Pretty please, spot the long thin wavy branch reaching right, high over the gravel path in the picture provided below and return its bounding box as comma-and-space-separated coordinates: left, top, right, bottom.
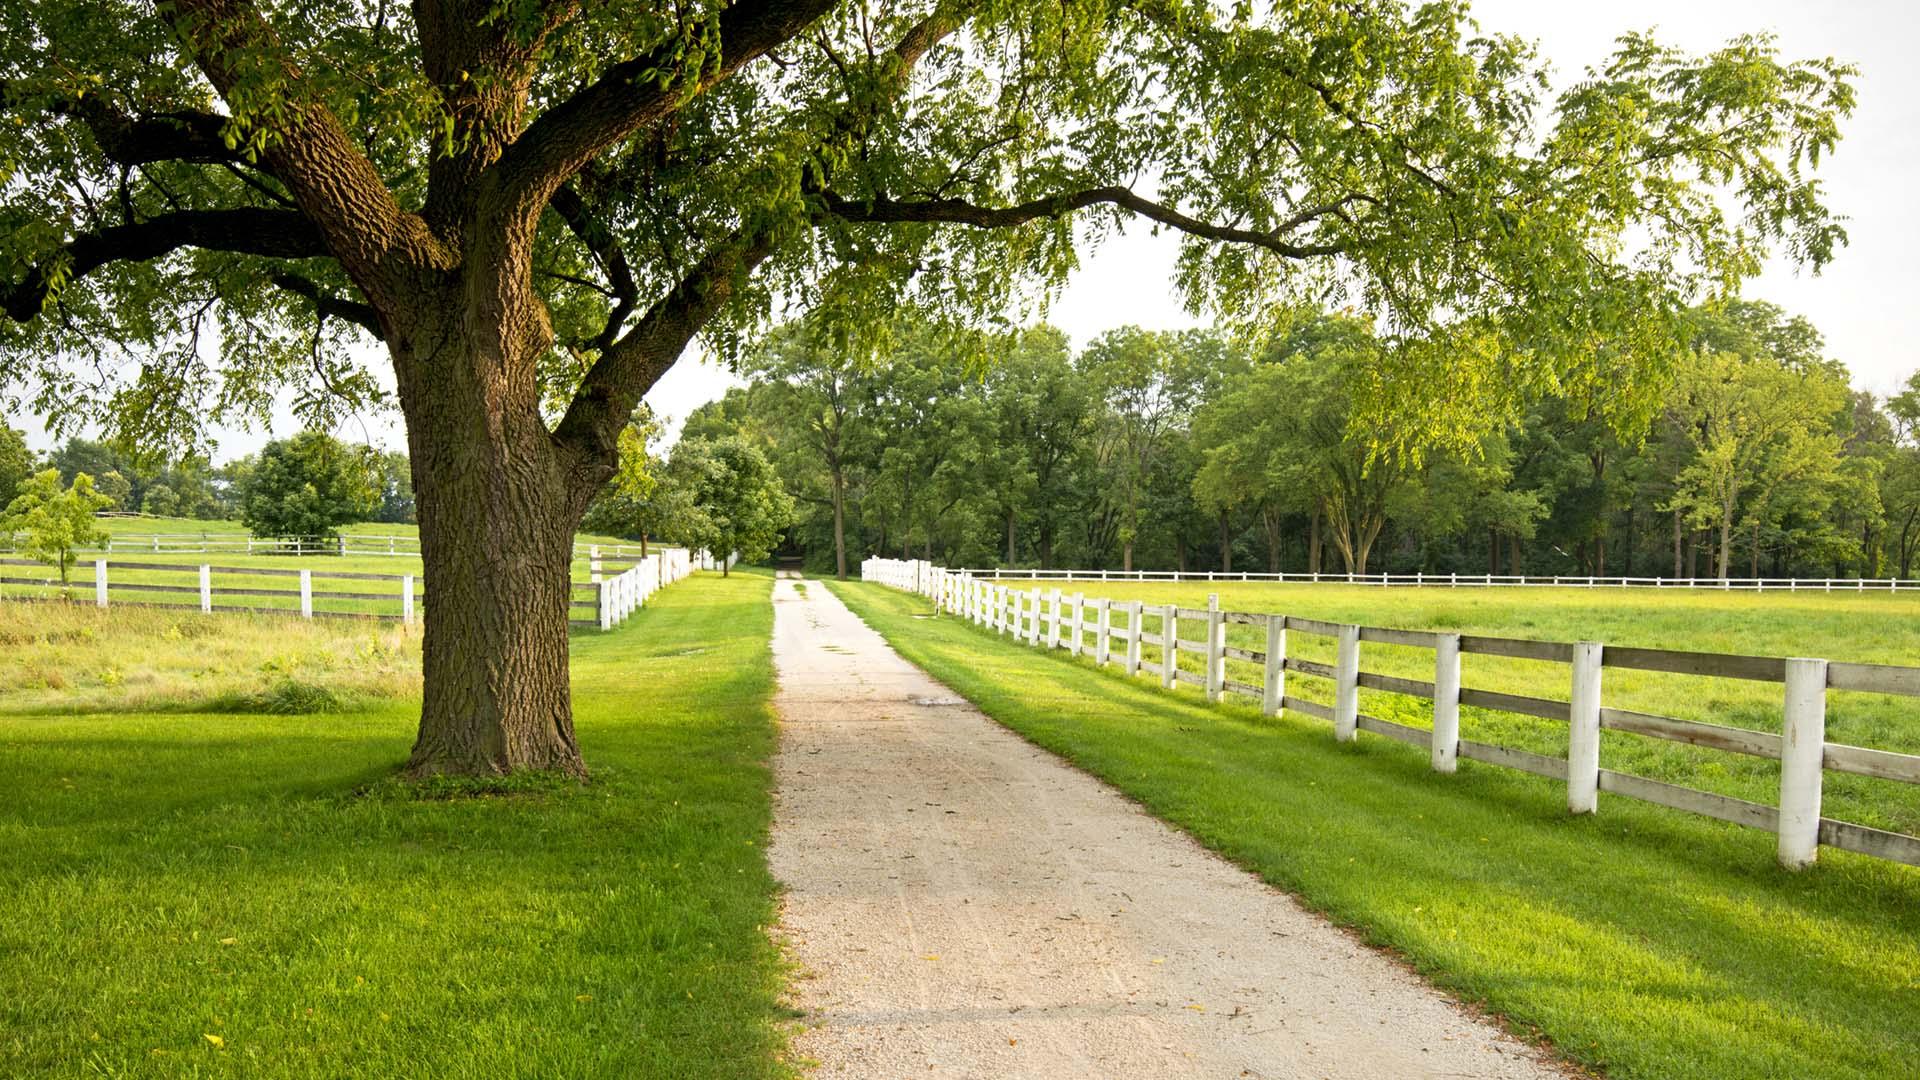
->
814, 186, 1346, 259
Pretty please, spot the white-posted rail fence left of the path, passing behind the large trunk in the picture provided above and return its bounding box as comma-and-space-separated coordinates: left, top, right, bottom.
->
0, 548, 716, 630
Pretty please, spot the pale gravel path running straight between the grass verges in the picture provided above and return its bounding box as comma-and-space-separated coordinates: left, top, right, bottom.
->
770, 580, 1563, 1080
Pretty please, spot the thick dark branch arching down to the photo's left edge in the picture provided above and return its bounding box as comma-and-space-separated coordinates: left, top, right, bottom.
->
0, 206, 328, 323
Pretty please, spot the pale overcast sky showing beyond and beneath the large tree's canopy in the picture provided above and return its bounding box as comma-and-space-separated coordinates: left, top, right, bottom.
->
13, 0, 1920, 459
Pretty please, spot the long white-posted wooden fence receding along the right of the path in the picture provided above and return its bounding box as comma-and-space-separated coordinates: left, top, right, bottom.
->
860, 559, 1920, 869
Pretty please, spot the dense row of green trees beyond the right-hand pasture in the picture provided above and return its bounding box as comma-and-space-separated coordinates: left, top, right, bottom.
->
685, 302, 1920, 577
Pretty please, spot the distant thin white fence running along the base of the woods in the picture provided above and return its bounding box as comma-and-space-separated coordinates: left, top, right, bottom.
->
952, 559, 1920, 592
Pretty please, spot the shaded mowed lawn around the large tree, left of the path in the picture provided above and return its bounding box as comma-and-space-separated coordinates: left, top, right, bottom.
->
0, 575, 783, 1078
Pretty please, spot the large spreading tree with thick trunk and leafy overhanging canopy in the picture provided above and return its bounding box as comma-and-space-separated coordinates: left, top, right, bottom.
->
0, 0, 1853, 773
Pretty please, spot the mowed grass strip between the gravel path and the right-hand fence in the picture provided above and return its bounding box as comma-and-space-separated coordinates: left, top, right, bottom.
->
833, 582, 1920, 1080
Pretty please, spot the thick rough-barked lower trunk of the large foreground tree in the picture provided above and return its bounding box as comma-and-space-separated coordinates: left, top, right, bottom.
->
394, 315, 591, 776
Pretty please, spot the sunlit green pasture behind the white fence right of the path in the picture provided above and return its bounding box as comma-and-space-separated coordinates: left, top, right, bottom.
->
975, 582, 1920, 834
